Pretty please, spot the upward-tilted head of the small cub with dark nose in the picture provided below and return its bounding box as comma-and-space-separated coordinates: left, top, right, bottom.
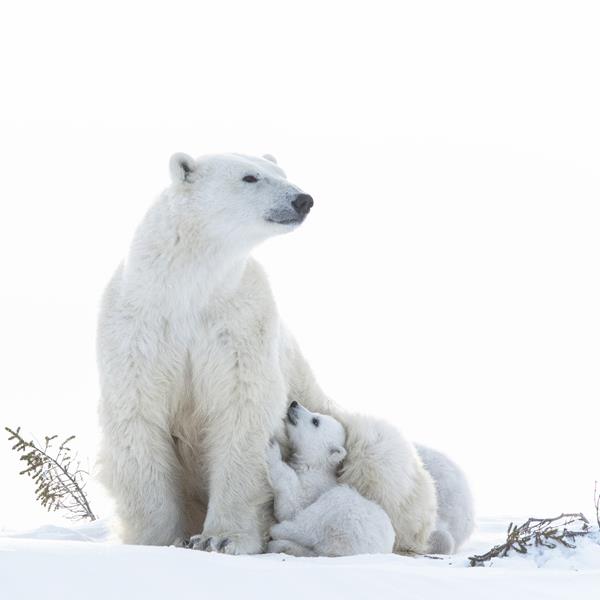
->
286, 402, 346, 470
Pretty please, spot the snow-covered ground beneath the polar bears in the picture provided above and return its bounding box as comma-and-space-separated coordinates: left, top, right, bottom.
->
0, 519, 600, 600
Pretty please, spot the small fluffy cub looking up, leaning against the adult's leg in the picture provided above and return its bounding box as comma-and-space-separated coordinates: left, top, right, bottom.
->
267, 402, 395, 556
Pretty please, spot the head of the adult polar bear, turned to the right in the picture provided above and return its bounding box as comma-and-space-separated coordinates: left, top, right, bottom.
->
170, 154, 313, 244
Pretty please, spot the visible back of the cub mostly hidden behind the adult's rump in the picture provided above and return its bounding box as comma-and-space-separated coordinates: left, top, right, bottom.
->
417, 445, 475, 554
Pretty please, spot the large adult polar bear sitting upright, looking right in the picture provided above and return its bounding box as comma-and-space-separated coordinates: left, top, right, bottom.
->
98, 154, 436, 554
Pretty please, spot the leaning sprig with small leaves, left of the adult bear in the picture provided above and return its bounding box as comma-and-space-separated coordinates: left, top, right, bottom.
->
5, 427, 96, 521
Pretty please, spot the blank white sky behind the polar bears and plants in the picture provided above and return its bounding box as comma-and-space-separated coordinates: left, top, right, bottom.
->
0, 0, 600, 526
